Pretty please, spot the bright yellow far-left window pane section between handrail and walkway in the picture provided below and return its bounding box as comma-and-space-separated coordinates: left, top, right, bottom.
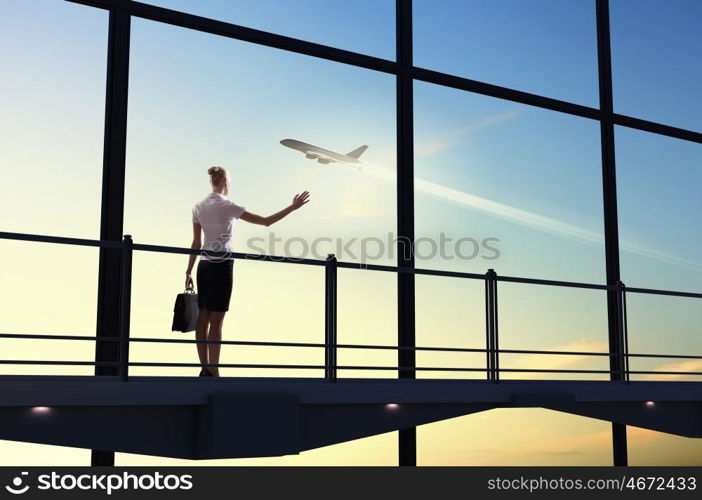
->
0, 240, 98, 375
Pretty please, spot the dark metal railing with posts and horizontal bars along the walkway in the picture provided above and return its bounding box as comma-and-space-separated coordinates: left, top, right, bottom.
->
0, 232, 702, 383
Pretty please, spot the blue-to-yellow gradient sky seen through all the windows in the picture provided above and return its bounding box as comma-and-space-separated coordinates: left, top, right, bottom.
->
0, 0, 702, 465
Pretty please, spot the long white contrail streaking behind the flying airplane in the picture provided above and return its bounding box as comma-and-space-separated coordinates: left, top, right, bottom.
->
362, 163, 702, 272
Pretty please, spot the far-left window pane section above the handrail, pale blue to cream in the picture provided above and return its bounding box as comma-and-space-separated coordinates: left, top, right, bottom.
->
0, 0, 108, 238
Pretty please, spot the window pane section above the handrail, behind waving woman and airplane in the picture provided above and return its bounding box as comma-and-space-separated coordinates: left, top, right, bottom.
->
125, 19, 396, 263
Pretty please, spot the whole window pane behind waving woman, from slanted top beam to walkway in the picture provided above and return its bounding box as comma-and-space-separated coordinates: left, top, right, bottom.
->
125, 19, 396, 377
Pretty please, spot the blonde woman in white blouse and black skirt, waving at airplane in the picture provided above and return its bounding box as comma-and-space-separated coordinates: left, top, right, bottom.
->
185, 167, 310, 377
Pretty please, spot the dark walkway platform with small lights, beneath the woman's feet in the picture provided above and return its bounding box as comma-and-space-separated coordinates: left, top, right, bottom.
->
0, 375, 702, 459
